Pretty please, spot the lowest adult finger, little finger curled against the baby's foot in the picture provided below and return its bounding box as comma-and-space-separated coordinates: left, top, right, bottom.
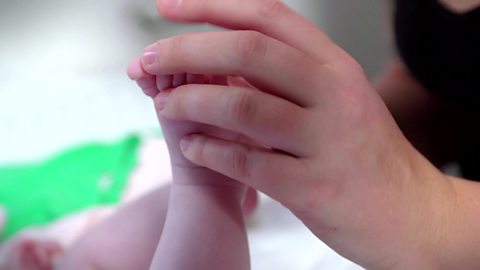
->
180, 135, 308, 205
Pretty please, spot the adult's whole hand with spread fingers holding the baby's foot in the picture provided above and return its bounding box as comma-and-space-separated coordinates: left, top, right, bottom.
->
142, 0, 454, 269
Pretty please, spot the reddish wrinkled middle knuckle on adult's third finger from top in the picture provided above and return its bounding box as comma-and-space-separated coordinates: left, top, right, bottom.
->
227, 92, 257, 124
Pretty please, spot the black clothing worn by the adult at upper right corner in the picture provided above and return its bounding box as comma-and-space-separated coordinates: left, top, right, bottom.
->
395, 0, 480, 181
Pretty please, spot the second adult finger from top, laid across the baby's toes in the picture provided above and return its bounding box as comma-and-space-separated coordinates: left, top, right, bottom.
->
142, 31, 322, 106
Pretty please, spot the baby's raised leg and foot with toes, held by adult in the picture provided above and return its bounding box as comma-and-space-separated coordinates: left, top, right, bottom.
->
128, 60, 250, 270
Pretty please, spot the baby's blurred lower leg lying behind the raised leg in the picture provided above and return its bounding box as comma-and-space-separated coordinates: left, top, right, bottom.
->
55, 186, 170, 270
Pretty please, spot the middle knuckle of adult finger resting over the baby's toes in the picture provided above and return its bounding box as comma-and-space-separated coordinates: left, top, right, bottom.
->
236, 30, 267, 66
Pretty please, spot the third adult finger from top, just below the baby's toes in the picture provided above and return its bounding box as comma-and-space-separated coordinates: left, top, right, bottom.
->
154, 85, 315, 157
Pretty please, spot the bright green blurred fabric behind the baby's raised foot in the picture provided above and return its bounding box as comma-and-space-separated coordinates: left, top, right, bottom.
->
0, 136, 140, 239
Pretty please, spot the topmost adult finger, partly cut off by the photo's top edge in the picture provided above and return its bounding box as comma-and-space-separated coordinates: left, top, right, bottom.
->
157, 0, 346, 63
